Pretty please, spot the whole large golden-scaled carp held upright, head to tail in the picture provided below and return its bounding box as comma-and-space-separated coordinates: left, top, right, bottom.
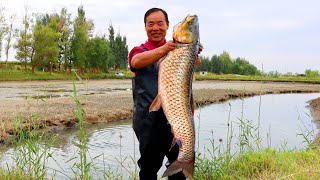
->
149, 15, 200, 179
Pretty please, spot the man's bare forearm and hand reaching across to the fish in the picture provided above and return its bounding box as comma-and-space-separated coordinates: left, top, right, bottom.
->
131, 41, 177, 69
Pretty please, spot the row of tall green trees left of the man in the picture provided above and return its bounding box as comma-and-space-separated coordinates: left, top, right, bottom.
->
0, 6, 128, 73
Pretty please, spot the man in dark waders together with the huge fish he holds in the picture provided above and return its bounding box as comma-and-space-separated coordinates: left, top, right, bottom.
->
129, 8, 202, 180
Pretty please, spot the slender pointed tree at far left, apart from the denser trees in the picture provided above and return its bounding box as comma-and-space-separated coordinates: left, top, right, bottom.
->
14, 7, 34, 69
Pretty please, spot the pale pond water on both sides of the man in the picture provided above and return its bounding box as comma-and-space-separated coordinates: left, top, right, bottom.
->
2, 93, 320, 179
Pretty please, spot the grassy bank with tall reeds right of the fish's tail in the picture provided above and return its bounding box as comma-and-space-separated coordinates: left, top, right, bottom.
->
194, 91, 320, 180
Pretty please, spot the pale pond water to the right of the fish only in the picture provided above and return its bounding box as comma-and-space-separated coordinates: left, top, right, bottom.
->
196, 93, 320, 152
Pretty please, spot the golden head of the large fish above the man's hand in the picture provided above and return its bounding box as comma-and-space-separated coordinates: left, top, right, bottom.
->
172, 15, 199, 44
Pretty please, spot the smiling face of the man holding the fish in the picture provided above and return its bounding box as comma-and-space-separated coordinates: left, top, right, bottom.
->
145, 11, 169, 43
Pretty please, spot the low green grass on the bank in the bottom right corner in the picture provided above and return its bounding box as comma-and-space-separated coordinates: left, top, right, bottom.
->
194, 147, 320, 180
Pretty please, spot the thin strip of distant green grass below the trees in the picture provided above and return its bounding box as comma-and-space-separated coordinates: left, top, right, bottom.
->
0, 63, 320, 84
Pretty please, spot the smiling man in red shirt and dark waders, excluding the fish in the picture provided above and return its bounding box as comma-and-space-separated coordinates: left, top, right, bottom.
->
129, 8, 200, 180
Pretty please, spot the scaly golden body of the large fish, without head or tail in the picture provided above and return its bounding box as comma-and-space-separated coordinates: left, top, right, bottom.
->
159, 45, 198, 162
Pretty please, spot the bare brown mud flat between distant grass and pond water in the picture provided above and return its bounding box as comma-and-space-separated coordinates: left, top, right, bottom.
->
0, 80, 320, 140
